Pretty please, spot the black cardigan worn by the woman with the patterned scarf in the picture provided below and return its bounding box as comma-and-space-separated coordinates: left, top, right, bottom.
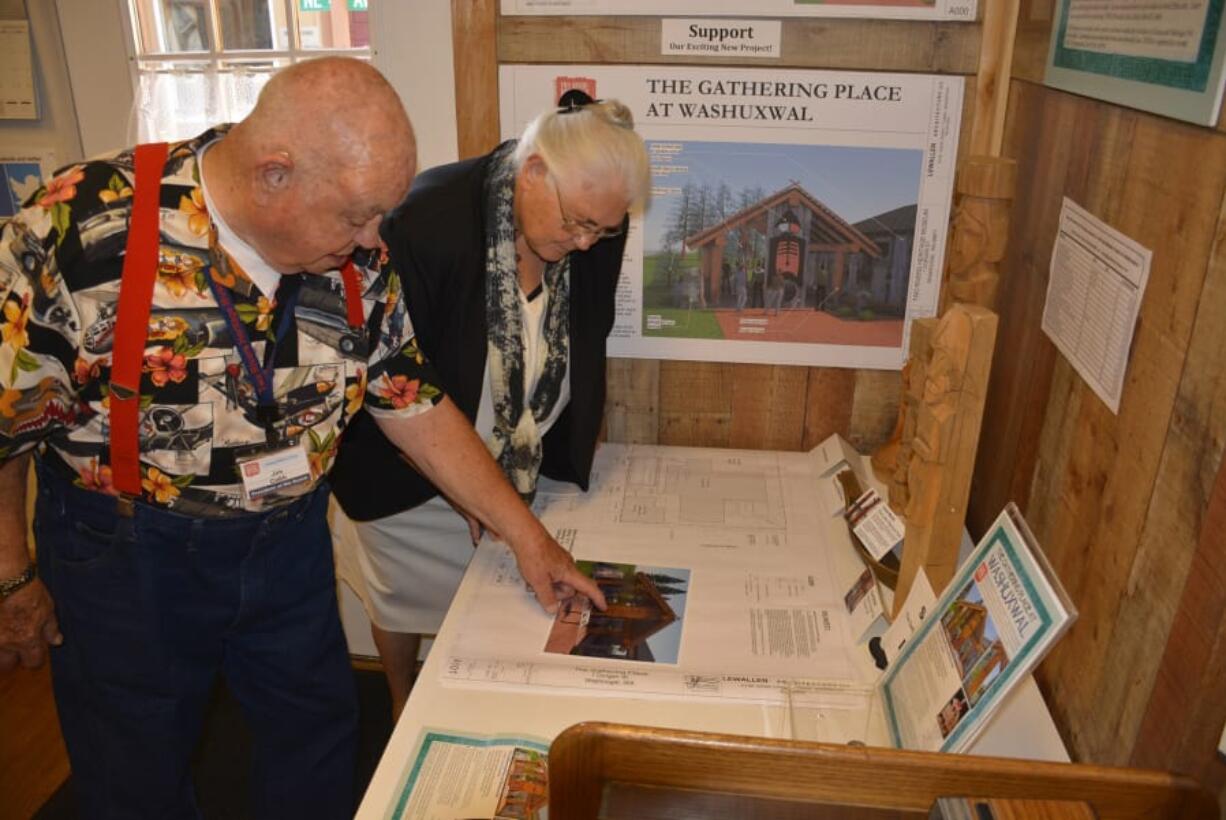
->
331, 144, 625, 521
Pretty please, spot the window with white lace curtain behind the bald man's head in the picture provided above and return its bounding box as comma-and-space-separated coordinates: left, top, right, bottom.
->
128, 0, 370, 142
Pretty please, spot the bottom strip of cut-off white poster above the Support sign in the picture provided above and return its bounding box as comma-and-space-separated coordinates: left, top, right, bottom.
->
503, 0, 976, 22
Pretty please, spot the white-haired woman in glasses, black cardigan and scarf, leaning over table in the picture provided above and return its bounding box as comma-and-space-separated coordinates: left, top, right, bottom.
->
331, 91, 651, 716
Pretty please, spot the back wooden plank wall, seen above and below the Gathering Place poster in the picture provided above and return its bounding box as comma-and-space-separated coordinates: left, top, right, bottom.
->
452, 0, 990, 451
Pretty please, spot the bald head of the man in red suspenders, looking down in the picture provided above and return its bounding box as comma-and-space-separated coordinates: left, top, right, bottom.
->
206, 58, 417, 272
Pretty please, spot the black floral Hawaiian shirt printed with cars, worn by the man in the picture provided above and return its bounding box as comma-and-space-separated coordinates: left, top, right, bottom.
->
0, 126, 443, 516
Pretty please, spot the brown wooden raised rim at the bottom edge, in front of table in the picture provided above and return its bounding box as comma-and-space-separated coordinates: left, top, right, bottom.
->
549, 723, 1219, 820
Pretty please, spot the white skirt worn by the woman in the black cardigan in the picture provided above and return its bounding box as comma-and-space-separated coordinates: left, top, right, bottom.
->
332, 496, 473, 635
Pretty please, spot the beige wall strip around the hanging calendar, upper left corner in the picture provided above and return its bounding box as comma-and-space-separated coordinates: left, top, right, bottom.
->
0, 0, 82, 165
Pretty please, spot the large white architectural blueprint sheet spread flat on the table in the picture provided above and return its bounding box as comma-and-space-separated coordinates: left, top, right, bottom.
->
441, 445, 873, 708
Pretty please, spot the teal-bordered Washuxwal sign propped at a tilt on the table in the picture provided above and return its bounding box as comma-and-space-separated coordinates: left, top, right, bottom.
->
790, 504, 1076, 751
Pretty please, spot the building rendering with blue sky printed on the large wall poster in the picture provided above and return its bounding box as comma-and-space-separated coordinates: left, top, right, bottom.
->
642, 141, 923, 347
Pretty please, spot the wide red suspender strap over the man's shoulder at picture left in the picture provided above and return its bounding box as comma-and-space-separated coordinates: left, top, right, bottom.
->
110, 142, 168, 496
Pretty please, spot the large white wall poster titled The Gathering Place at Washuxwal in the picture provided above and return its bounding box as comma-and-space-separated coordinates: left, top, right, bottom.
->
499, 65, 964, 369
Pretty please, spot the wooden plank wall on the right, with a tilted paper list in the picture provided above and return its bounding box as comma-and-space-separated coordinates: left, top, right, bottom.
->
969, 0, 1226, 804
